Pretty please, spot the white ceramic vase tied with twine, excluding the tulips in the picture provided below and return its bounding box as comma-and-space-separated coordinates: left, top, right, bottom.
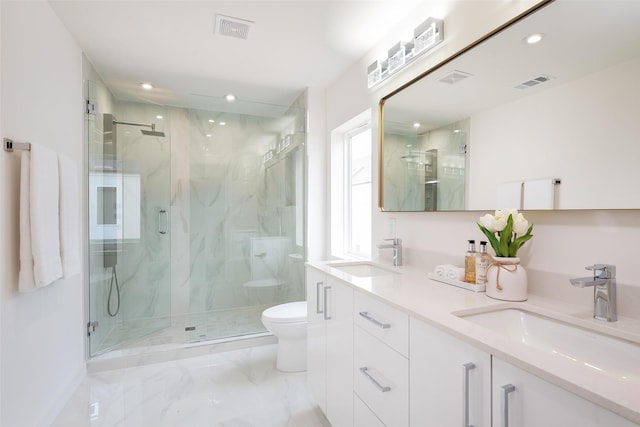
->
486, 257, 527, 301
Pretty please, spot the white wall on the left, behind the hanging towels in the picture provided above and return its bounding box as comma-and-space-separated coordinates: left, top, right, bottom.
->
0, 1, 86, 427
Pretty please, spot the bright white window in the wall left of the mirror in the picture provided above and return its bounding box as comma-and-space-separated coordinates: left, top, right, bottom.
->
330, 110, 373, 258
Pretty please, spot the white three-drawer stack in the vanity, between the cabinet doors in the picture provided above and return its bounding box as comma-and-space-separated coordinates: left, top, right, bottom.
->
352, 291, 409, 427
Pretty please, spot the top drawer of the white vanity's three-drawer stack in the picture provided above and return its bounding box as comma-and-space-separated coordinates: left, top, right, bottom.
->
354, 292, 409, 357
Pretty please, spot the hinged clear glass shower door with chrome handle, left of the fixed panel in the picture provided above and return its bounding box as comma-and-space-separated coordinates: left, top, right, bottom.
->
87, 81, 171, 356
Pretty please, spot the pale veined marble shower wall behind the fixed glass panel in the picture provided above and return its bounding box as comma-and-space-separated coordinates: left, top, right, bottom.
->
184, 104, 303, 313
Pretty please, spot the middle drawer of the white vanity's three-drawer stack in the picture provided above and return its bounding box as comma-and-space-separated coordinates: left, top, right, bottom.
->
353, 326, 409, 427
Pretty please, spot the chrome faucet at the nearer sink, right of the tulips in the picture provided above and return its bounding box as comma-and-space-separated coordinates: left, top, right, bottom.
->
569, 264, 618, 322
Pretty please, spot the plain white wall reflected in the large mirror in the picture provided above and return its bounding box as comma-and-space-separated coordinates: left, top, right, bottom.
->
467, 59, 640, 209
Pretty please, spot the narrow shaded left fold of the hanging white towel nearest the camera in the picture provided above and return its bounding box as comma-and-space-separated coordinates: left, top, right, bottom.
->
18, 151, 36, 292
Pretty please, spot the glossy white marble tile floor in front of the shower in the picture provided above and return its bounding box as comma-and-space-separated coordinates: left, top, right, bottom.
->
52, 344, 330, 427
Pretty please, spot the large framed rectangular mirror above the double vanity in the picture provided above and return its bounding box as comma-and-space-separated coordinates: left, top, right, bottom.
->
379, 0, 640, 211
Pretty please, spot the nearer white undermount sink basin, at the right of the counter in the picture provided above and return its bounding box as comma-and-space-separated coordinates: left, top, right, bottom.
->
457, 308, 640, 381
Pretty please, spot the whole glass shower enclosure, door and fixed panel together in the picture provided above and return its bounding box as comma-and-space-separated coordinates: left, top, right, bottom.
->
87, 80, 305, 356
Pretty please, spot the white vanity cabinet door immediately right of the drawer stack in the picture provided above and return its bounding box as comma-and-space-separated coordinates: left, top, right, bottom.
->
409, 317, 491, 427
